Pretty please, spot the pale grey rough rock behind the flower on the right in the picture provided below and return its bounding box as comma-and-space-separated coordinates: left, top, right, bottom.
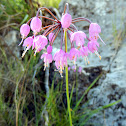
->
59, 0, 126, 126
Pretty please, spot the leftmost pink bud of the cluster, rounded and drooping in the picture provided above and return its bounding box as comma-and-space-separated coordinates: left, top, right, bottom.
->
20, 24, 30, 38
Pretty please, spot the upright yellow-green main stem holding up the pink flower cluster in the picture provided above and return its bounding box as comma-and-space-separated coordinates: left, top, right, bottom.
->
64, 30, 72, 126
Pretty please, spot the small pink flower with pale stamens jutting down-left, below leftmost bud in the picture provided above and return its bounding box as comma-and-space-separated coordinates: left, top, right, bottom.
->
22, 37, 33, 57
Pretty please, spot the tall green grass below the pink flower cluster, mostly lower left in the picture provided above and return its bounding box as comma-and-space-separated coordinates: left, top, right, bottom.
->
0, 45, 120, 126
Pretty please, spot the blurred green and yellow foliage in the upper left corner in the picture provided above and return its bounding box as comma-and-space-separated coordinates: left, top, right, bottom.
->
0, 0, 61, 30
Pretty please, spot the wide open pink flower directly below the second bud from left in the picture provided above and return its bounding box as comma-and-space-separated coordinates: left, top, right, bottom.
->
32, 35, 48, 54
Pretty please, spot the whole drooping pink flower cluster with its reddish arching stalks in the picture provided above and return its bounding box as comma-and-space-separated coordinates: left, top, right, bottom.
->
19, 4, 102, 76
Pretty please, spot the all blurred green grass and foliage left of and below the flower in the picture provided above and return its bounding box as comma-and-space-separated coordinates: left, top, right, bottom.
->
0, 0, 119, 126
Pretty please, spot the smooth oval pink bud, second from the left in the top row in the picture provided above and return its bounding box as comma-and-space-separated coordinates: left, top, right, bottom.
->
30, 17, 42, 33
